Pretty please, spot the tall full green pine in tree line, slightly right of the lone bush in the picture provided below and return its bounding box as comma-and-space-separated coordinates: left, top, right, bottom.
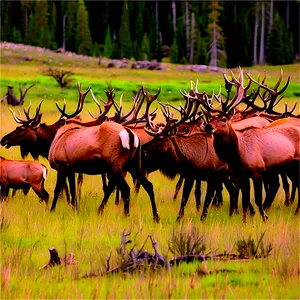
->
75, 0, 92, 55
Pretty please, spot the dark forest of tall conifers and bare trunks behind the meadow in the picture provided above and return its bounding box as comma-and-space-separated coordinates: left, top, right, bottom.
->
1, 0, 300, 67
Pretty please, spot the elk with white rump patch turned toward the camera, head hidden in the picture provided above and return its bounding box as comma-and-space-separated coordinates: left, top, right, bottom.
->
48, 90, 159, 221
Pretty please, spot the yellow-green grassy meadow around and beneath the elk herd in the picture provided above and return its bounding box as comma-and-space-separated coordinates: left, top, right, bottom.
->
0, 43, 300, 299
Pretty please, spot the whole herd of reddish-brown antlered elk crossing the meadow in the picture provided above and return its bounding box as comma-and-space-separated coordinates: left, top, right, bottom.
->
0, 68, 300, 222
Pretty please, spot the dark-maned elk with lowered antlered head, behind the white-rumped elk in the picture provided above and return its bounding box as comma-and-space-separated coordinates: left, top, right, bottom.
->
142, 88, 237, 221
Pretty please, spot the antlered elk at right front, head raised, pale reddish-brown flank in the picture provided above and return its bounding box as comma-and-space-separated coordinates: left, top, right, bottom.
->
202, 69, 300, 222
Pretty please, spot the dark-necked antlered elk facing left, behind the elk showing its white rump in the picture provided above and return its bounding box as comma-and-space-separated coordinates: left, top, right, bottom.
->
1, 82, 90, 203
